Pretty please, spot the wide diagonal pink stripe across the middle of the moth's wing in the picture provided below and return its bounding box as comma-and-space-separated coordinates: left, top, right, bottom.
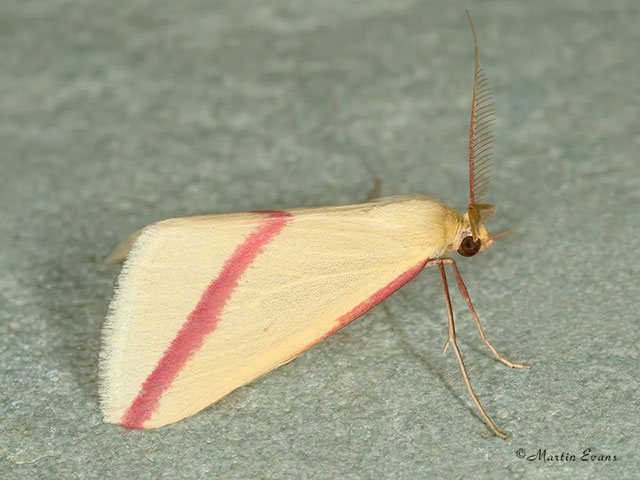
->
121, 210, 293, 428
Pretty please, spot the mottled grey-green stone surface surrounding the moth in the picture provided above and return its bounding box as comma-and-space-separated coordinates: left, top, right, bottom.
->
0, 0, 640, 479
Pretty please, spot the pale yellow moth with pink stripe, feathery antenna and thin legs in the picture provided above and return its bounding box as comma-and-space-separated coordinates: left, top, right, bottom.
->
100, 14, 528, 438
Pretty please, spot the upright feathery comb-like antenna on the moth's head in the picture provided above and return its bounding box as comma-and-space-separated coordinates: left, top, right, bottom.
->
466, 10, 495, 205
